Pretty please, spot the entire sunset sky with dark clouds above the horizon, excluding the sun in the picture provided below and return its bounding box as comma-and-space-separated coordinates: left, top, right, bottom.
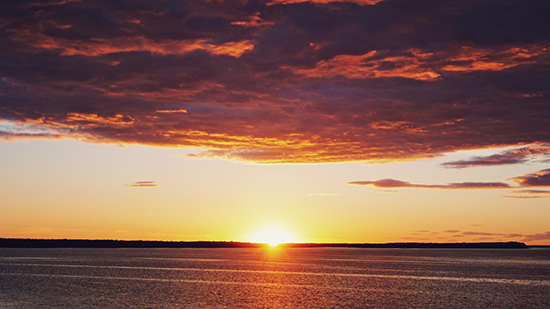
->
0, 0, 550, 245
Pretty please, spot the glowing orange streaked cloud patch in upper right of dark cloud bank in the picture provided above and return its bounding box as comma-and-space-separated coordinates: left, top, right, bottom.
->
292, 45, 550, 82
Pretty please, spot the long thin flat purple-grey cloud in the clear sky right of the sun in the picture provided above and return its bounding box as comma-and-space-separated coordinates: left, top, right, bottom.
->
348, 178, 510, 190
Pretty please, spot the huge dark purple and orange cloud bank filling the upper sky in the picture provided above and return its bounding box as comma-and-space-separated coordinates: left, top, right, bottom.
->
0, 0, 550, 162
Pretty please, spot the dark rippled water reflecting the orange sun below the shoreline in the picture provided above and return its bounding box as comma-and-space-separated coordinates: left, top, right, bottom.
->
0, 248, 550, 308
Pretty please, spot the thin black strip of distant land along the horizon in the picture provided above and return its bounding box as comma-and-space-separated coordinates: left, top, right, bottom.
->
0, 238, 529, 249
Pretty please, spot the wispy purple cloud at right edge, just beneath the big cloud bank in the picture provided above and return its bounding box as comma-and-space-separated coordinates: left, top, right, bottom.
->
441, 144, 550, 168
